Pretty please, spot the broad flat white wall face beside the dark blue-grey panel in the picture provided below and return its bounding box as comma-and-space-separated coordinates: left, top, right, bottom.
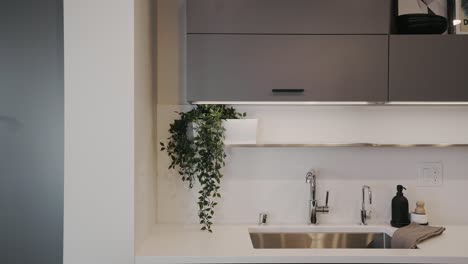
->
64, 0, 135, 264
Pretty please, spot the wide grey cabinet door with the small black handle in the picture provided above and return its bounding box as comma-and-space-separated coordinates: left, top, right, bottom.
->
187, 34, 388, 102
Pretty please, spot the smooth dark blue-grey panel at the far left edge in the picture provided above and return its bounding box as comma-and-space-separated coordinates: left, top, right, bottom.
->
0, 0, 64, 264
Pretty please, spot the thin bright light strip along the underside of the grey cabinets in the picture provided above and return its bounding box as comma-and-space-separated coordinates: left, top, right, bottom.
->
192, 101, 468, 106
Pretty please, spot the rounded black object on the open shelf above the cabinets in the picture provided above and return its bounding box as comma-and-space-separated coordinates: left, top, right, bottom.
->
396, 14, 448, 34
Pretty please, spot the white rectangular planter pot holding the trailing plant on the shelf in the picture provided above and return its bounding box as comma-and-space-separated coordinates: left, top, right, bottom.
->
188, 119, 258, 145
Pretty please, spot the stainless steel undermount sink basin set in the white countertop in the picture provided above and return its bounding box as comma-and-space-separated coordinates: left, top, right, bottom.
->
250, 232, 392, 249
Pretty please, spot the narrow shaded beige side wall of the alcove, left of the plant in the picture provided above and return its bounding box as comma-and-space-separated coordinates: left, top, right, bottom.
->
135, 0, 157, 251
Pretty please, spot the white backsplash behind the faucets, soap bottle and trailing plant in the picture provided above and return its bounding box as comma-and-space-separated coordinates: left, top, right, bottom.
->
157, 105, 468, 224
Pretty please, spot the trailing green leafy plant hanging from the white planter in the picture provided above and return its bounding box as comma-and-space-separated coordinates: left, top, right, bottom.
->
160, 105, 246, 232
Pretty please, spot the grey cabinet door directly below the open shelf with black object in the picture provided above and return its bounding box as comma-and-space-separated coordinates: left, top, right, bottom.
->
390, 35, 468, 102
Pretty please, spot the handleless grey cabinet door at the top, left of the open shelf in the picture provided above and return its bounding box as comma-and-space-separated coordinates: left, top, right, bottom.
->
187, 0, 391, 34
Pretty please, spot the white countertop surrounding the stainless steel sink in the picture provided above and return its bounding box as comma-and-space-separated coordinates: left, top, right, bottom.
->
136, 225, 468, 264
